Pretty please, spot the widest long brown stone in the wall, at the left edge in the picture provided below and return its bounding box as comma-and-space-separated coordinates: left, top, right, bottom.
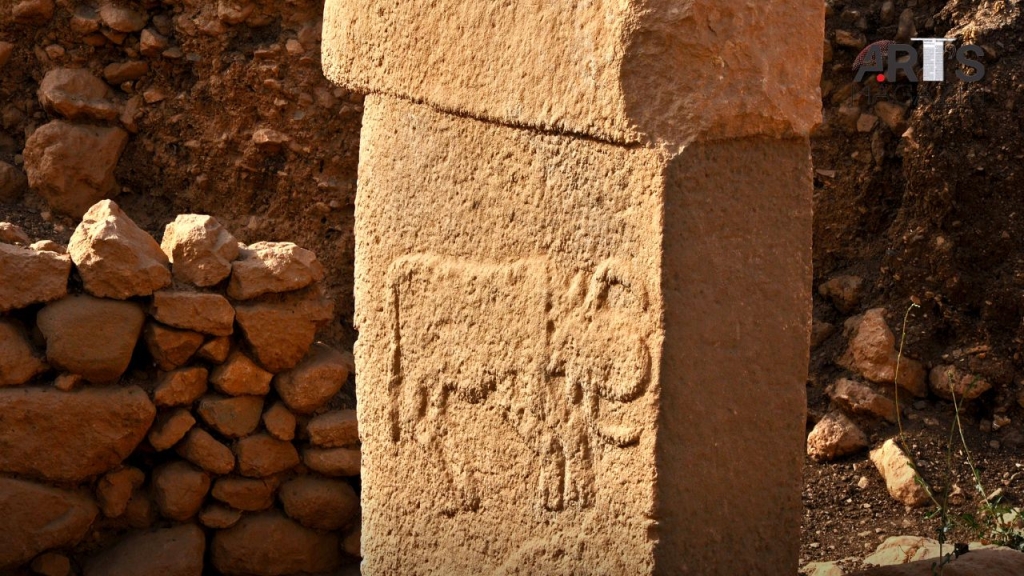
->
0, 386, 156, 482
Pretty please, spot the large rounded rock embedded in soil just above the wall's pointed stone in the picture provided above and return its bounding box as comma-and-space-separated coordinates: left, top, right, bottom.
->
25, 120, 128, 218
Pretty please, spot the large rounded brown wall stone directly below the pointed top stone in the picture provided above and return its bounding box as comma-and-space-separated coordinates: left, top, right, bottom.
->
37, 295, 145, 382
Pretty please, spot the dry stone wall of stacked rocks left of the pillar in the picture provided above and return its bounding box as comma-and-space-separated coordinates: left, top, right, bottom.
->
0, 200, 360, 576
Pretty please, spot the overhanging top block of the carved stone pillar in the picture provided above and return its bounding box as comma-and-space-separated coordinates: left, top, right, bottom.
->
323, 0, 824, 145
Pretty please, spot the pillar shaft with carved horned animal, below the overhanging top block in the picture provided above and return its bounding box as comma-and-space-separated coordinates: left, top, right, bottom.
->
354, 96, 820, 575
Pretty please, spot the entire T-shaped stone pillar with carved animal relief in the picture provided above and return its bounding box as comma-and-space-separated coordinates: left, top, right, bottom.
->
324, 0, 824, 576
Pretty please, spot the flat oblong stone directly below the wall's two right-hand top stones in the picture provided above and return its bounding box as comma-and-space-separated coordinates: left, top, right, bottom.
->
150, 290, 234, 336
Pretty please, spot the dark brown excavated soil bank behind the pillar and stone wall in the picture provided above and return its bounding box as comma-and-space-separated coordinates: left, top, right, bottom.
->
6, 0, 1024, 563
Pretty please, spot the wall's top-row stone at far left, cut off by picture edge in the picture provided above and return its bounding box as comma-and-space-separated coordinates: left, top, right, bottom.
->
0, 239, 71, 312
